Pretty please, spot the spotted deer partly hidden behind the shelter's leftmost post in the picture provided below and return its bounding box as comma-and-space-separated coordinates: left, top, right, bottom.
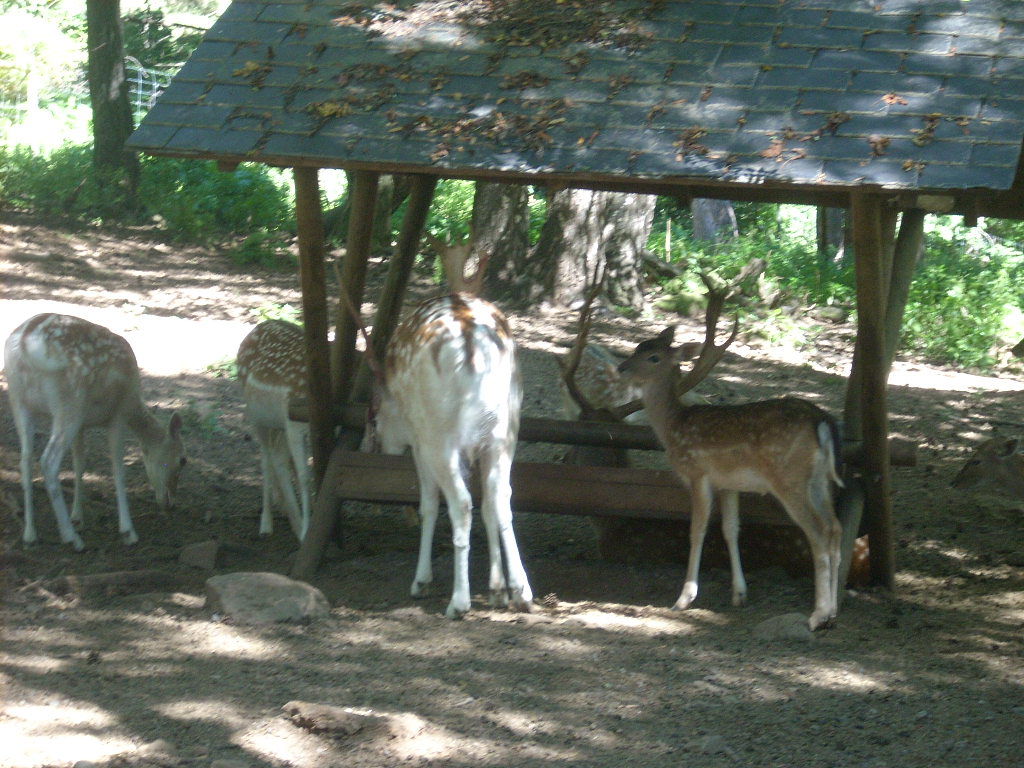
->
237, 319, 312, 541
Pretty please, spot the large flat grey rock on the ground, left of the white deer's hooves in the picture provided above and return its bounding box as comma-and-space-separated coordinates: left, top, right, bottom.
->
206, 572, 331, 624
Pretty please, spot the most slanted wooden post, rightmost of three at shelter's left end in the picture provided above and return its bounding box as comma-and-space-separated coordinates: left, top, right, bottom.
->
351, 176, 437, 402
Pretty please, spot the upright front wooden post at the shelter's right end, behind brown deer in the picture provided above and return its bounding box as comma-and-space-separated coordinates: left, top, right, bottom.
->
850, 193, 896, 589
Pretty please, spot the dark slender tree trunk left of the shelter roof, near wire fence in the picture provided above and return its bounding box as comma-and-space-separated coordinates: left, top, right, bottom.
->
86, 0, 139, 204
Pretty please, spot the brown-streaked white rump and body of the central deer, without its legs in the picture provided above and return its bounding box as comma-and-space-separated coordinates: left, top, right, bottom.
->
377, 294, 522, 453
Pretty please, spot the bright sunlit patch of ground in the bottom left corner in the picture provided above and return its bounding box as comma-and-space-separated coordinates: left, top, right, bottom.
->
0, 701, 134, 768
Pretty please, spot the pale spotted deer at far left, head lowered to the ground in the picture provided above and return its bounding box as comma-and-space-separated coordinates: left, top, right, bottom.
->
4, 313, 187, 551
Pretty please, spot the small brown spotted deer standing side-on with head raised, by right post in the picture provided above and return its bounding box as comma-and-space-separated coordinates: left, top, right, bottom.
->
620, 292, 843, 630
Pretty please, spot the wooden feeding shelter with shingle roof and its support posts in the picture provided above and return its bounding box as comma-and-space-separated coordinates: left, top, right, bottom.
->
129, 0, 1024, 586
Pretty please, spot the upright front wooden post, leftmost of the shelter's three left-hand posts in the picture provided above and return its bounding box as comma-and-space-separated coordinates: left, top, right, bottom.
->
293, 168, 335, 482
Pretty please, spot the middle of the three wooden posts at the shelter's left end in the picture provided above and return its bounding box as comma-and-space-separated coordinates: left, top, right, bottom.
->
332, 171, 380, 402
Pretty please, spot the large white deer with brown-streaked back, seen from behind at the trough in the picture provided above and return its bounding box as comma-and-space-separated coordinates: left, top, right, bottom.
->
367, 293, 534, 618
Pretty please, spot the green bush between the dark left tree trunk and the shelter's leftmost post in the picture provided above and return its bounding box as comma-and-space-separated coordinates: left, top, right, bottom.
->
140, 158, 295, 240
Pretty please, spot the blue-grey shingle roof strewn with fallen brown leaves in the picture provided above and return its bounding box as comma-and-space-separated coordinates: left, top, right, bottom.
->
129, 0, 1024, 195
